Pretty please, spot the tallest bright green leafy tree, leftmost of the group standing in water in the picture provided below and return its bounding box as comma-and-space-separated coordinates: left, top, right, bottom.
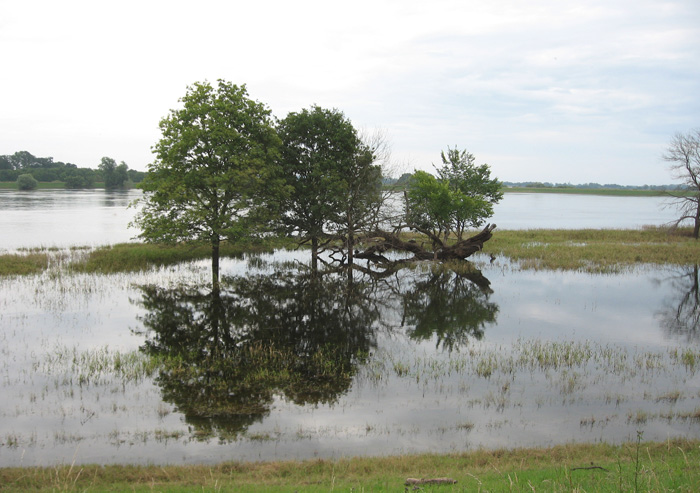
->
134, 80, 279, 290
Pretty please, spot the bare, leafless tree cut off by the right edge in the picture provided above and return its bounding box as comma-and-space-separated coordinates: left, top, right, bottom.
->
664, 129, 700, 240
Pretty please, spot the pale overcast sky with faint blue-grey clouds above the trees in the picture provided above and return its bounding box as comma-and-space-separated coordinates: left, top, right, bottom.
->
0, 0, 700, 185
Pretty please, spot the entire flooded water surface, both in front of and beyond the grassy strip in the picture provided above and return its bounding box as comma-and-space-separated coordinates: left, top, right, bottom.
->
0, 191, 700, 466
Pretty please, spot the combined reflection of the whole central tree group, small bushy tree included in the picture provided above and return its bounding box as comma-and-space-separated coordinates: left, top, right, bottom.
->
139, 269, 498, 440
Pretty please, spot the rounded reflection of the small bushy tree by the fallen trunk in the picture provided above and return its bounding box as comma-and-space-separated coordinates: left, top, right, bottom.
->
402, 268, 498, 350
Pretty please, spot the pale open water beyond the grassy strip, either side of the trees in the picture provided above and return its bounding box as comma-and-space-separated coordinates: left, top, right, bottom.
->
0, 190, 675, 251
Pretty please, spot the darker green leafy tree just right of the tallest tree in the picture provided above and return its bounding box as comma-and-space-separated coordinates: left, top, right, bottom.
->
278, 106, 381, 268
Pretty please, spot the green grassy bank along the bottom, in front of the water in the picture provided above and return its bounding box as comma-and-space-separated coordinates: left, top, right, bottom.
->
0, 440, 700, 492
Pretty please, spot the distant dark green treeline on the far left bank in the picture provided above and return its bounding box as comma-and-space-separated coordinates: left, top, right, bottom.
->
0, 151, 146, 188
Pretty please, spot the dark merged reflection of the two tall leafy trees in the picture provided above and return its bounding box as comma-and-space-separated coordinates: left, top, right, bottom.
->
135, 272, 378, 439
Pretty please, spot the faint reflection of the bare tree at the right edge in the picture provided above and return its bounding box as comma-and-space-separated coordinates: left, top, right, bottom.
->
661, 265, 700, 342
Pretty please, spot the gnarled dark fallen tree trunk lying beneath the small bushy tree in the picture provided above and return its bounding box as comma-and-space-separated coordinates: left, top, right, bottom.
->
355, 224, 496, 262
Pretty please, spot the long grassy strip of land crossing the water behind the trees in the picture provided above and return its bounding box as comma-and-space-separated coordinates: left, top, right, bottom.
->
0, 228, 700, 276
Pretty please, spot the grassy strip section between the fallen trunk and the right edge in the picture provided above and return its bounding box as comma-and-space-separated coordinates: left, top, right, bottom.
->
484, 228, 700, 272
